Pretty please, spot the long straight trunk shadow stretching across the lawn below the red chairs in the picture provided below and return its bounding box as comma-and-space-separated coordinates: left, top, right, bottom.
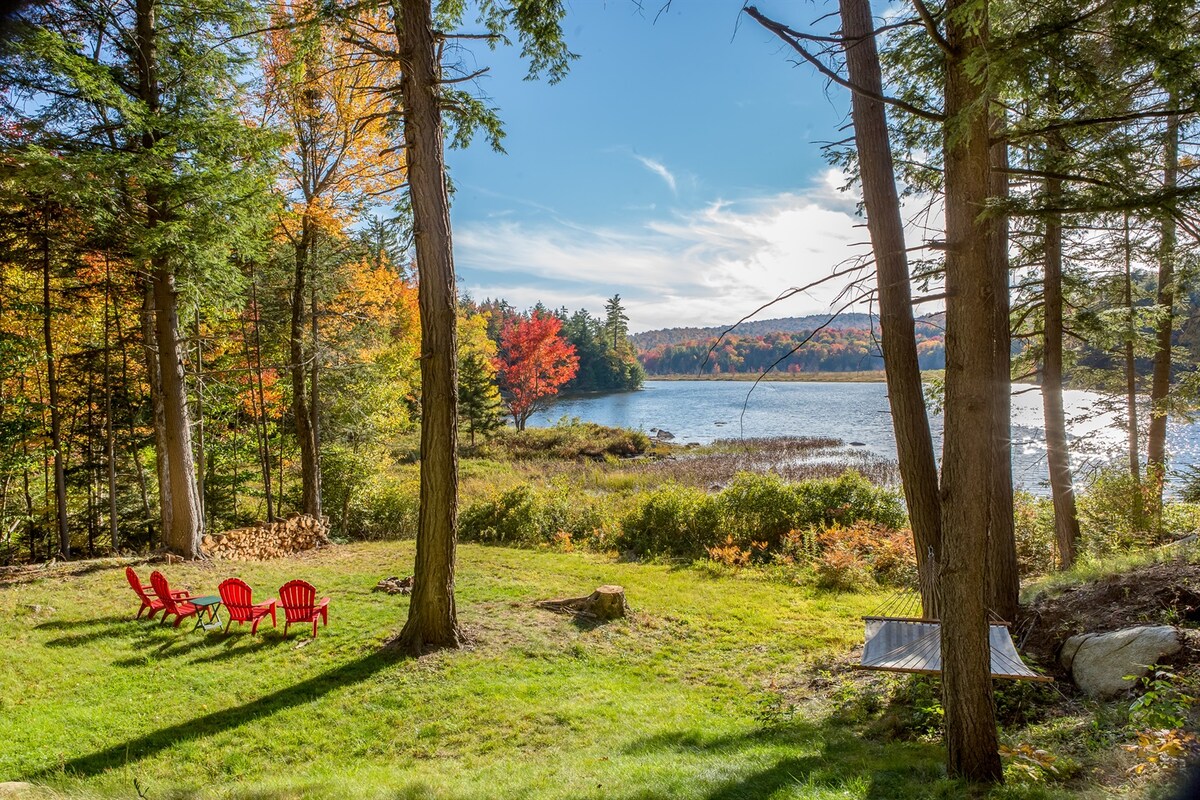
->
25, 649, 406, 782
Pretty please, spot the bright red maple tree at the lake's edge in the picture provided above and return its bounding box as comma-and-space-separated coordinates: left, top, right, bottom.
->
496, 311, 580, 431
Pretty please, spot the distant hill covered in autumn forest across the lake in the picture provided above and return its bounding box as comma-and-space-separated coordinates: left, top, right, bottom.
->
631, 314, 946, 375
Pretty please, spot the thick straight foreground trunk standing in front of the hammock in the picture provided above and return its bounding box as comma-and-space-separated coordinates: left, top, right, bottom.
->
938, 0, 1002, 781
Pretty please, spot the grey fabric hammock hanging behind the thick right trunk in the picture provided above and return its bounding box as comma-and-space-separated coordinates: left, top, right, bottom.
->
858, 591, 1054, 682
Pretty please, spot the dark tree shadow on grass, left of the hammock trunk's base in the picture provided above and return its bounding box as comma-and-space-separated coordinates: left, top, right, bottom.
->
625, 720, 959, 800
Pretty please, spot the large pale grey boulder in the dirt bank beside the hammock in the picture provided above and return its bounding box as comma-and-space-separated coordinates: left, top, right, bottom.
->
1060, 625, 1183, 698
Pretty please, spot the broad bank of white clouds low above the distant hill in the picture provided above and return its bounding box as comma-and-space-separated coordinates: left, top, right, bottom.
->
455, 169, 931, 331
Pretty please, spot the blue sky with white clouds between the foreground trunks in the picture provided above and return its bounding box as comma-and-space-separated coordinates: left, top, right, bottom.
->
448, 0, 866, 331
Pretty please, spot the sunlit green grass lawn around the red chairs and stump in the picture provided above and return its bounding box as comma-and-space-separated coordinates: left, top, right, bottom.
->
0, 542, 1142, 800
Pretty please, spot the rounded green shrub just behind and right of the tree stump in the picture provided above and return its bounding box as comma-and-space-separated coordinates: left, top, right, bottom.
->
613, 483, 721, 558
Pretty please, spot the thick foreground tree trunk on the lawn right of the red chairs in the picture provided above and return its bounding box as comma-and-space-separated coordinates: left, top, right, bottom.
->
392, 0, 462, 654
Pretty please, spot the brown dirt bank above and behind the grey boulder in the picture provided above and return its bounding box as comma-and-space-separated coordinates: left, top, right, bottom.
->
1013, 561, 1200, 674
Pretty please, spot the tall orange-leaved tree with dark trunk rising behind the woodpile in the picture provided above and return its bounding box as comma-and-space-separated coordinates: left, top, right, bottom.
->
262, 0, 404, 517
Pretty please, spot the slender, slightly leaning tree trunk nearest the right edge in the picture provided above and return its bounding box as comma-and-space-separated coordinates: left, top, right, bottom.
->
1146, 112, 1180, 506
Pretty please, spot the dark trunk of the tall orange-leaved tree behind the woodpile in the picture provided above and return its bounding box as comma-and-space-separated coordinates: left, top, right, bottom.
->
290, 220, 320, 518
